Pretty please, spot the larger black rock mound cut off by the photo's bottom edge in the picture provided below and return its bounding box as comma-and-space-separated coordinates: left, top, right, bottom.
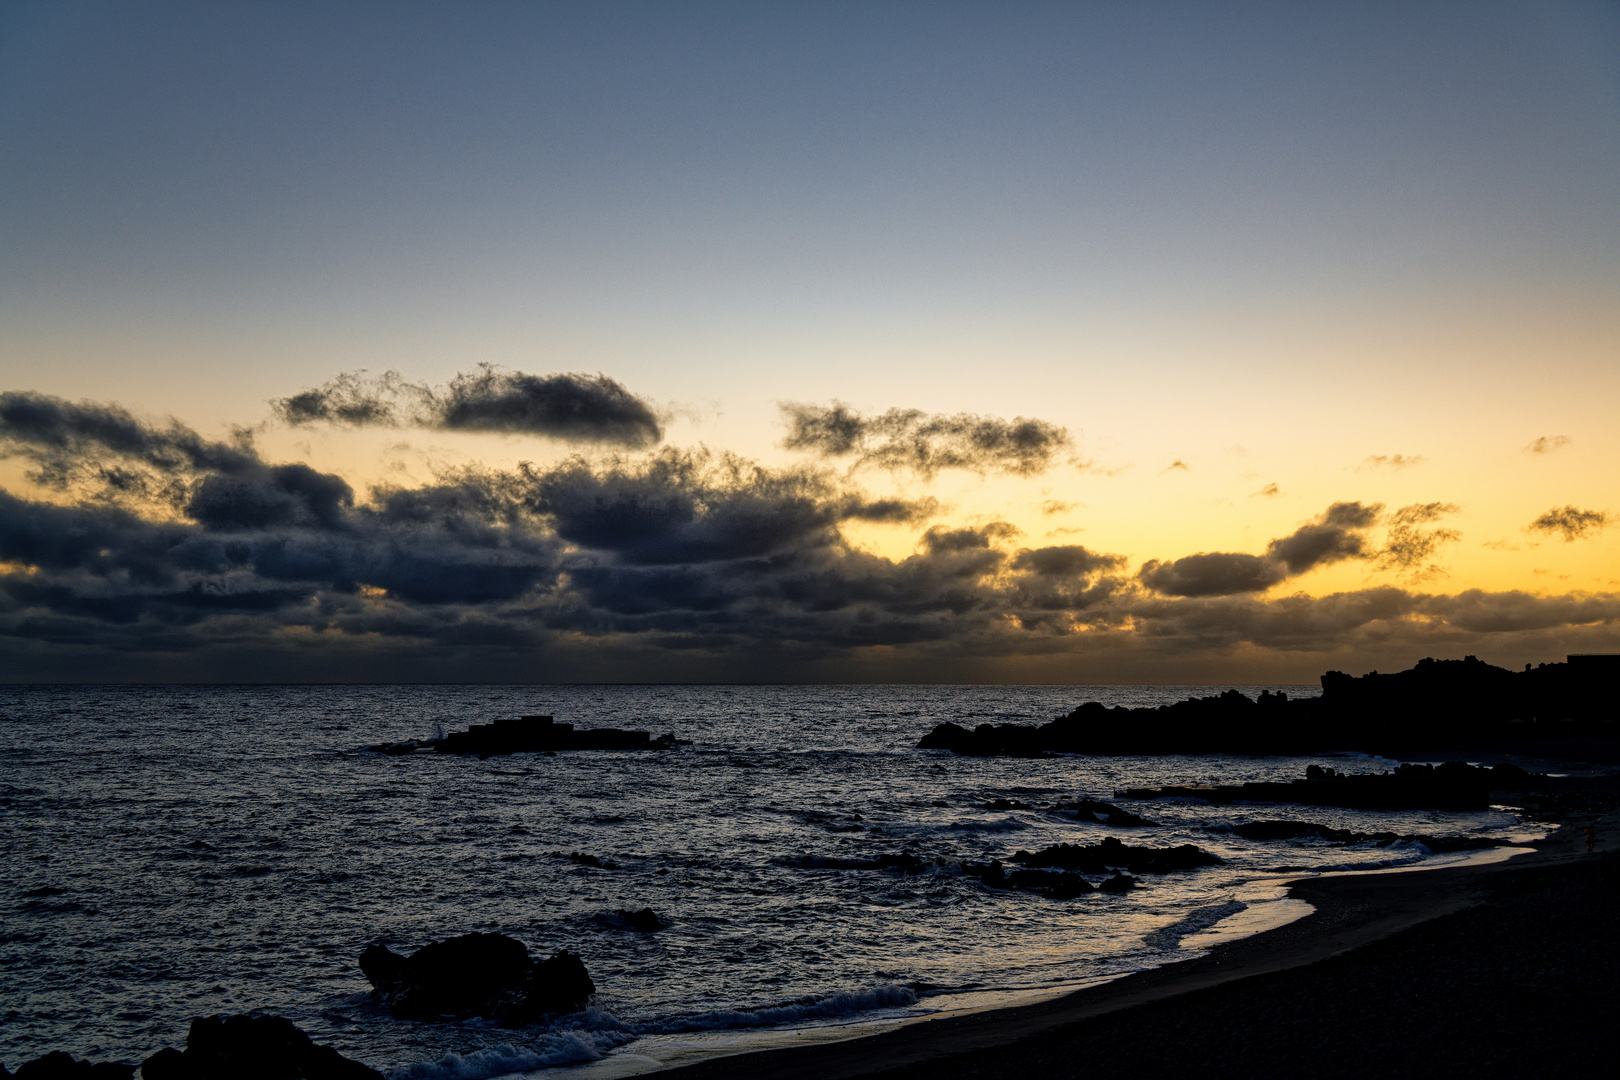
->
136, 1015, 382, 1080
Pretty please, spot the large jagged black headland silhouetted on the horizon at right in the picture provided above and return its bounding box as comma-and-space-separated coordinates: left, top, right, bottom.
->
917, 656, 1620, 761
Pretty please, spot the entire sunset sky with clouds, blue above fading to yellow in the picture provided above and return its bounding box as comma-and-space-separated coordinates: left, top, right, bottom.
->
0, 2, 1620, 683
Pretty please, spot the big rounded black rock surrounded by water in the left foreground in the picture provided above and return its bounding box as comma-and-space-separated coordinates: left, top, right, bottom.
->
360, 934, 596, 1027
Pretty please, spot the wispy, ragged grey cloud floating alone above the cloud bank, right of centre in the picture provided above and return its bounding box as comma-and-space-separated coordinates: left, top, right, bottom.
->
781, 402, 1074, 476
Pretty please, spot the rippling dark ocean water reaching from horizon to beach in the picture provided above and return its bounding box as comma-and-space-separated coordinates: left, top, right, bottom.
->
0, 685, 1544, 1080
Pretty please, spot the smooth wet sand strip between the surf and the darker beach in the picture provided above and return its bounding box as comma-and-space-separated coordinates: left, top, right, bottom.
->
635, 813, 1620, 1080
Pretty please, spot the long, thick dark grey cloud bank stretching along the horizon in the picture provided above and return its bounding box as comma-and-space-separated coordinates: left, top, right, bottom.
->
0, 381, 1620, 680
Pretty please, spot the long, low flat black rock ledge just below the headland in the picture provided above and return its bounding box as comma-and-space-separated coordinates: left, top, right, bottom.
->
1118, 761, 1526, 810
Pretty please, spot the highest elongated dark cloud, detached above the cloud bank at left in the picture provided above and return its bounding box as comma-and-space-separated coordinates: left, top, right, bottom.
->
271, 364, 664, 449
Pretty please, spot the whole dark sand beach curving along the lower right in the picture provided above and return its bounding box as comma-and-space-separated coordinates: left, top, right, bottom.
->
659, 813, 1620, 1080
